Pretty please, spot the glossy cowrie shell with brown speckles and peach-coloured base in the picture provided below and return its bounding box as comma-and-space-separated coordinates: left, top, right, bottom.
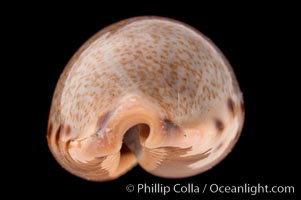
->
47, 17, 244, 181
